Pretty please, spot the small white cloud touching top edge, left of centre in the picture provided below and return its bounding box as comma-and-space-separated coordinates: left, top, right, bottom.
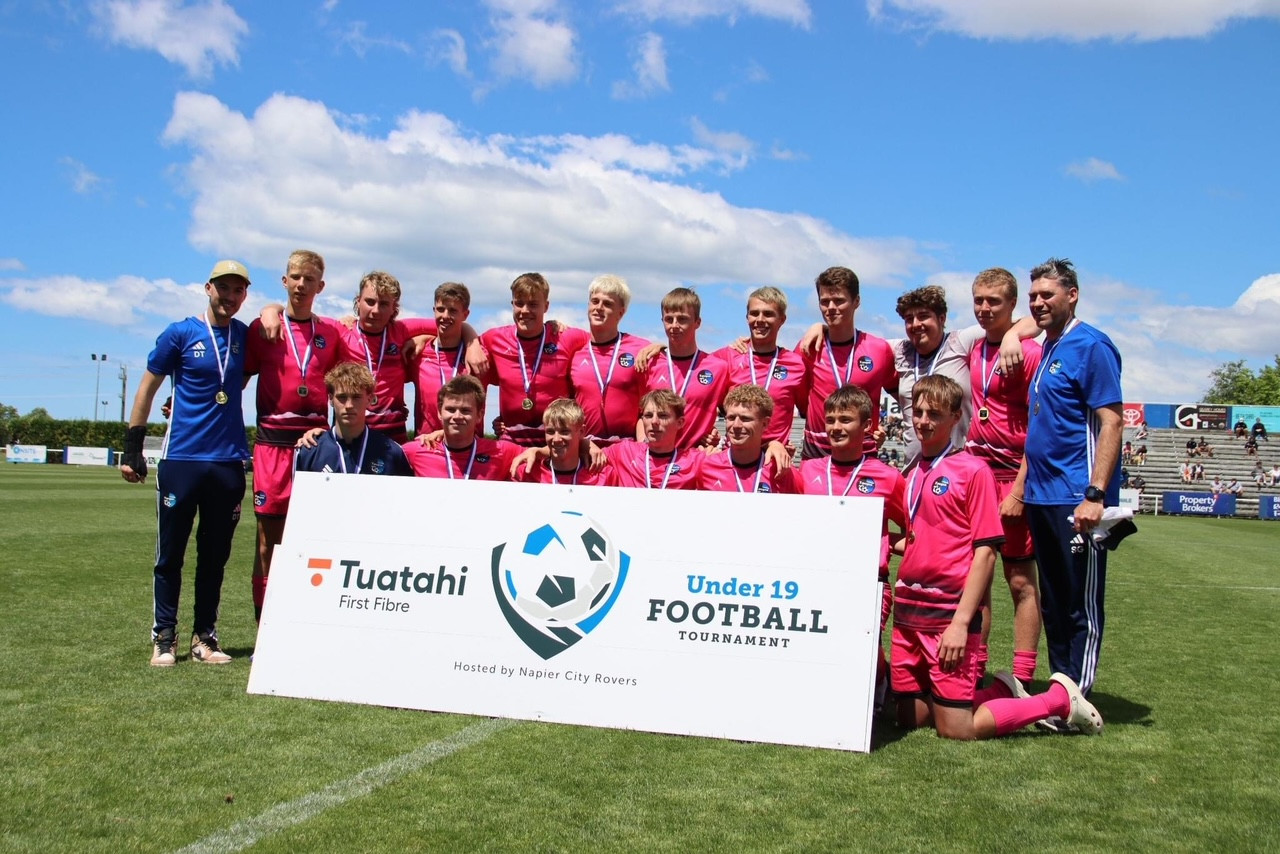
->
486, 0, 577, 88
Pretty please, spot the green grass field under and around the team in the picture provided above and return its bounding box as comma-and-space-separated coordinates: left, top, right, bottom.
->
0, 466, 1280, 851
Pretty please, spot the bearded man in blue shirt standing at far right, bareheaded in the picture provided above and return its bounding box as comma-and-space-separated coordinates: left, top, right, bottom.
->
1012, 259, 1124, 717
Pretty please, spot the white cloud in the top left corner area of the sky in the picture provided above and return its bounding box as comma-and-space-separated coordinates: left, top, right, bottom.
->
91, 0, 248, 78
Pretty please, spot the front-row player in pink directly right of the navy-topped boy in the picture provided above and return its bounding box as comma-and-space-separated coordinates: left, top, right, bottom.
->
404, 374, 520, 480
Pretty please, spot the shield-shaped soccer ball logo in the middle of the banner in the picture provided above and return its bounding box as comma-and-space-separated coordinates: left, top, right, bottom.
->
493, 511, 630, 659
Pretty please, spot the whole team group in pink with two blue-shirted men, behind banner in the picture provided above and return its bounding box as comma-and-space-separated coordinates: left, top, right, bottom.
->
122, 251, 1123, 739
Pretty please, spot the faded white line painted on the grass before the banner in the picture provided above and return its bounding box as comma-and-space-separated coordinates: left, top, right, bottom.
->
178, 718, 517, 854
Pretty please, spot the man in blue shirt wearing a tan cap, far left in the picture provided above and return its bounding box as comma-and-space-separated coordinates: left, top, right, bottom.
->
120, 261, 250, 667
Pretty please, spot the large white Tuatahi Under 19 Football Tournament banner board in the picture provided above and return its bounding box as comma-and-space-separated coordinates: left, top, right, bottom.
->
248, 472, 882, 752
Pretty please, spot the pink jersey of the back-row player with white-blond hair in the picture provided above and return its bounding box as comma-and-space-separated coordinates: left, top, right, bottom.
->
570, 333, 649, 446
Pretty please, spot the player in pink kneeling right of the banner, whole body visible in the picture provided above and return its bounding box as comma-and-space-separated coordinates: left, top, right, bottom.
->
890, 375, 1102, 740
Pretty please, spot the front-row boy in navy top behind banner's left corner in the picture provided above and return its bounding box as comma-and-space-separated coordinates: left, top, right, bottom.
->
293, 362, 413, 476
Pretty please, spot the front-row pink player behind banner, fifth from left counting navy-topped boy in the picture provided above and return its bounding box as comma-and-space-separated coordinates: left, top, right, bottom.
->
698, 385, 799, 495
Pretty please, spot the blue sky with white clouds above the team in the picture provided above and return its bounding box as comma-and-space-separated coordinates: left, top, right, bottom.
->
0, 0, 1280, 417
